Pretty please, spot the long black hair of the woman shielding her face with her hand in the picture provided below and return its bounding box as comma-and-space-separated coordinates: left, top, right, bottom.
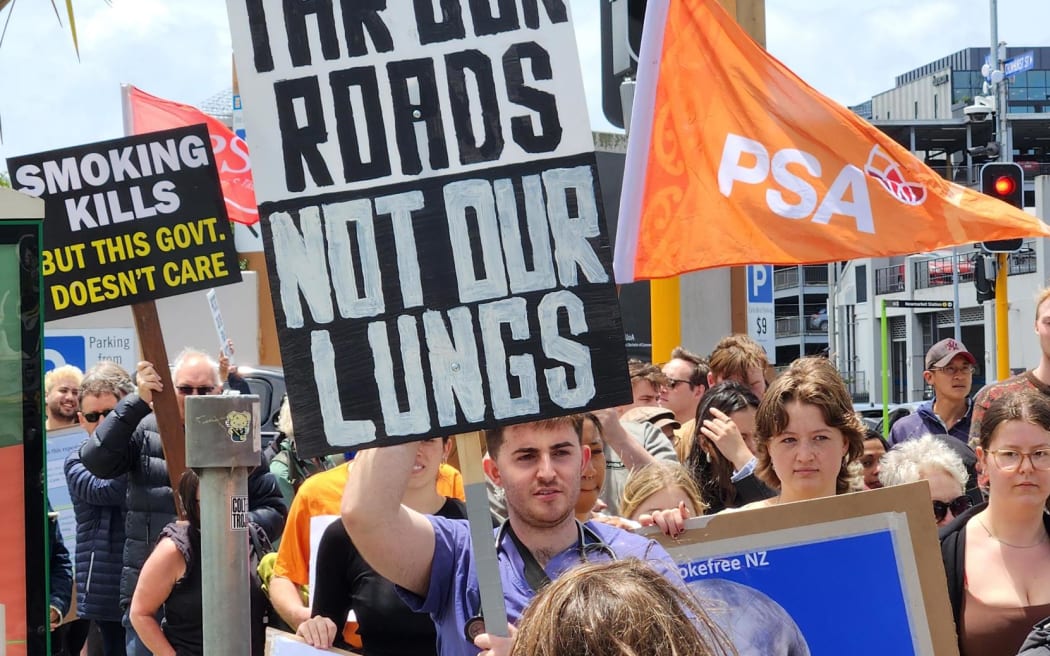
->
679, 380, 758, 512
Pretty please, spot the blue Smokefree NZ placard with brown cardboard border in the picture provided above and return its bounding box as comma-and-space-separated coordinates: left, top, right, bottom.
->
654, 481, 959, 656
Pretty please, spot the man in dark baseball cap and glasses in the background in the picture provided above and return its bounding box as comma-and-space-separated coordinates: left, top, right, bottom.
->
889, 338, 977, 444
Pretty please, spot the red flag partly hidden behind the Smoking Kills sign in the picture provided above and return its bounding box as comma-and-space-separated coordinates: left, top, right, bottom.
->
128, 85, 259, 226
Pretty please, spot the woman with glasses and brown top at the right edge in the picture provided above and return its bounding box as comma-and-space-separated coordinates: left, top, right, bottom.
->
941, 390, 1050, 656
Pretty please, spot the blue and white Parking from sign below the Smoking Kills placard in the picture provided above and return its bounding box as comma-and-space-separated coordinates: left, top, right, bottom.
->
44, 327, 139, 373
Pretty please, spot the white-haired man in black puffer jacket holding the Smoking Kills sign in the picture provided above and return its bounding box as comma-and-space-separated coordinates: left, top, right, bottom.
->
80, 348, 288, 656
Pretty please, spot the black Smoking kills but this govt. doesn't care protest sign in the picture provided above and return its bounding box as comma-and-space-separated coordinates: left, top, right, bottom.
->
7, 125, 240, 320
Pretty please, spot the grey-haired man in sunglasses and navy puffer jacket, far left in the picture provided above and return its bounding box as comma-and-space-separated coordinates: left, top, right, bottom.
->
65, 362, 134, 656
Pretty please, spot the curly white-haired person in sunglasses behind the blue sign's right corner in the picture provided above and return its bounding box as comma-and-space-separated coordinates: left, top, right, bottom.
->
879, 436, 973, 526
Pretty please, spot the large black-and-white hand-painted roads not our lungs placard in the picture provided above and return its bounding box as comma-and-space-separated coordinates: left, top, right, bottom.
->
228, 0, 630, 456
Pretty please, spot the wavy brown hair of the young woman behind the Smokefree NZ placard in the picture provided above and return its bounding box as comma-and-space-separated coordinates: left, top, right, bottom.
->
755, 356, 865, 494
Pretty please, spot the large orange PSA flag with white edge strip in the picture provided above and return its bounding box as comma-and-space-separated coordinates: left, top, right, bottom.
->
614, 0, 1050, 282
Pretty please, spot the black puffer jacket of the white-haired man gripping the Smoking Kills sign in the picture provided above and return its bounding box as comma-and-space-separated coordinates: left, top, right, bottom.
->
80, 394, 288, 609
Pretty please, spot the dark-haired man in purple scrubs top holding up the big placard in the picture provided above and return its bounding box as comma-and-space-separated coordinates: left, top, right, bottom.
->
342, 416, 681, 656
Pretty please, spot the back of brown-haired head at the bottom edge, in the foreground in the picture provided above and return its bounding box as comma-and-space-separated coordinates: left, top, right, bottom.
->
510, 558, 736, 656
